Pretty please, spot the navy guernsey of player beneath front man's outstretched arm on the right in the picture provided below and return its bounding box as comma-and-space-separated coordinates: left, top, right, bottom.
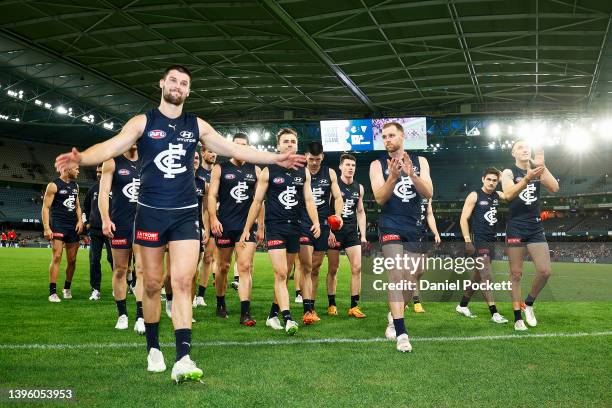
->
218, 160, 257, 231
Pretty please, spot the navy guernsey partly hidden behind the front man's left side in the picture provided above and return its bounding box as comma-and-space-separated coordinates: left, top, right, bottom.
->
110, 155, 140, 228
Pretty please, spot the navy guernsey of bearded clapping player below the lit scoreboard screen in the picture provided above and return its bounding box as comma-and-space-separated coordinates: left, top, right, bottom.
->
378, 153, 422, 230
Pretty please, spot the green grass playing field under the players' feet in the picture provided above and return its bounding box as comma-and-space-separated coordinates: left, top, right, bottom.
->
0, 248, 612, 408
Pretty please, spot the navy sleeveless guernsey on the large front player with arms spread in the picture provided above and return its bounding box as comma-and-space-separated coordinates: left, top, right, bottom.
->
138, 108, 200, 209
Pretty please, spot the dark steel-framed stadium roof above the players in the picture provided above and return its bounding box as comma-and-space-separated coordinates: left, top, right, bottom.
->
0, 0, 612, 126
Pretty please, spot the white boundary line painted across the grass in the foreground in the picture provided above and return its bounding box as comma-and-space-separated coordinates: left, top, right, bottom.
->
0, 330, 612, 350
